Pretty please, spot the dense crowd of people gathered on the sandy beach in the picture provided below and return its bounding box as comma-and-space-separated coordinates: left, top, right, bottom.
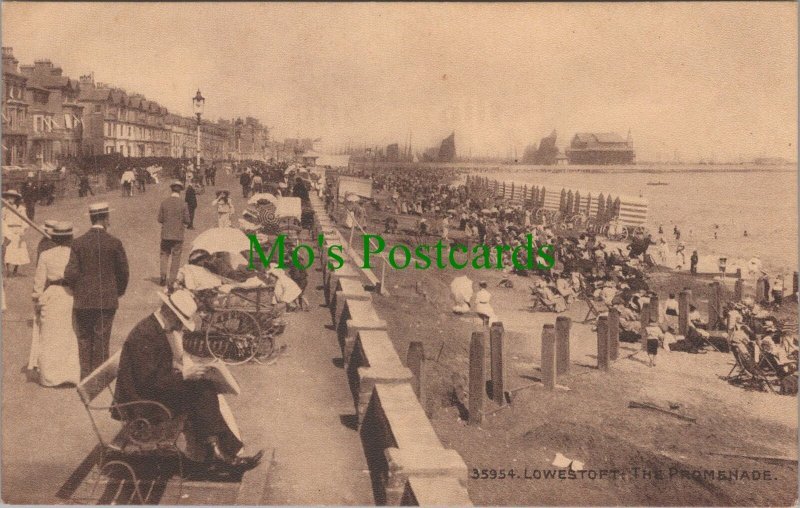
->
328, 168, 796, 378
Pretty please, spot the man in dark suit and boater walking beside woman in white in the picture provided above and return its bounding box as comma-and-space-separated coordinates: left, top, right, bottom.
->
64, 203, 129, 378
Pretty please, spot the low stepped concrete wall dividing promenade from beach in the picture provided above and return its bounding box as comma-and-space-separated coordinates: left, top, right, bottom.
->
311, 195, 472, 506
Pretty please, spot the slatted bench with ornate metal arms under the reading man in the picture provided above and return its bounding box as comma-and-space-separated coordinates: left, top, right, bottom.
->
73, 351, 184, 504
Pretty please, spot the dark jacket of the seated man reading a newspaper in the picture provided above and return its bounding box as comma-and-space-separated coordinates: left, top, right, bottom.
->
113, 314, 186, 418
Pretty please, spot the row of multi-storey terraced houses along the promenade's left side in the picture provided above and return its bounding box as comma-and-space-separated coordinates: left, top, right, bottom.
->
2, 47, 271, 168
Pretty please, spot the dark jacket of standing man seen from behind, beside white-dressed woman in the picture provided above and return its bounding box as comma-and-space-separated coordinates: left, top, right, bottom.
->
64, 227, 129, 309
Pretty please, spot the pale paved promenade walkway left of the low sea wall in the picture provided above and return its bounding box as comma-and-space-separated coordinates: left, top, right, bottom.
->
2, 172, 373, 504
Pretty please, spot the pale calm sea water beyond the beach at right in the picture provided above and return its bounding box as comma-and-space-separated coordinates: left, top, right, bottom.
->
466, 166, 797, 277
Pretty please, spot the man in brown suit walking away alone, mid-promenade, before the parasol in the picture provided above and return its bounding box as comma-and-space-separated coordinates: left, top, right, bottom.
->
158, 180, 191, 286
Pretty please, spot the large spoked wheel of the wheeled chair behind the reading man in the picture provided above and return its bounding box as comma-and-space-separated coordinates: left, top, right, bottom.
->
206, 310, 261, 365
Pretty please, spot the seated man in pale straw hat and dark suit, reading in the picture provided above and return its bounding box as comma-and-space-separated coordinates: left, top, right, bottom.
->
114, 289, 263, 471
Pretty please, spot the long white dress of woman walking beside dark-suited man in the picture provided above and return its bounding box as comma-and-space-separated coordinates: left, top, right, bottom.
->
33, 245, 81, 386
